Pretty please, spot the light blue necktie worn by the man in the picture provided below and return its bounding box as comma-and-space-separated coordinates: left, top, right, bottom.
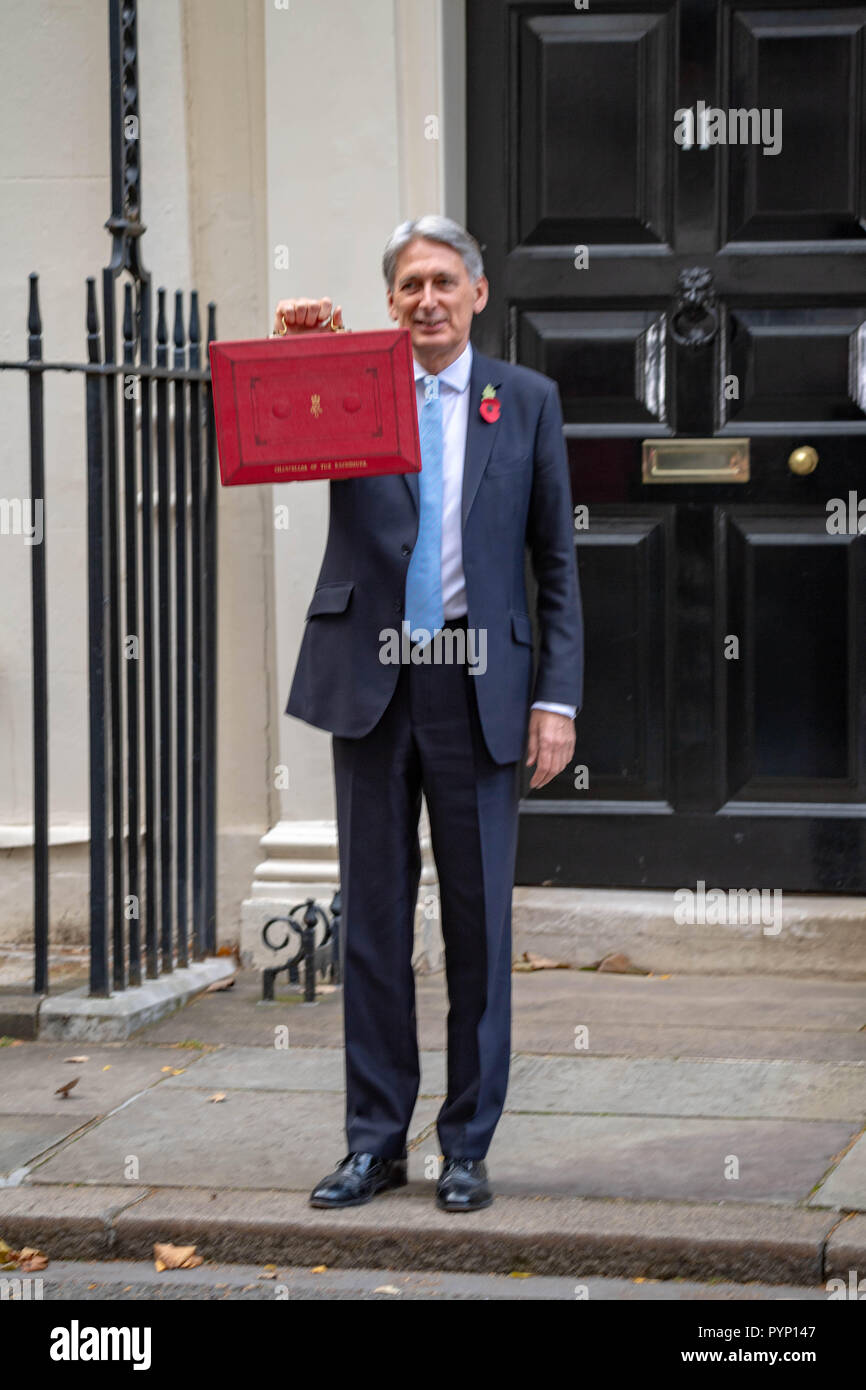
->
403, 375, 445, 637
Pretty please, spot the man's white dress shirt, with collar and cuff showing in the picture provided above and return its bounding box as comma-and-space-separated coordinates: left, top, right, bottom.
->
414, 343, 577, 719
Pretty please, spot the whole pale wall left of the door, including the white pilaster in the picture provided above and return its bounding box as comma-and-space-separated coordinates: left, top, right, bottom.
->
0, 0, 464, 941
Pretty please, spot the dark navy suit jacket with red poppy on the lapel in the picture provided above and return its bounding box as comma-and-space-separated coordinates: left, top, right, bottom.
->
285, 349, 584, 763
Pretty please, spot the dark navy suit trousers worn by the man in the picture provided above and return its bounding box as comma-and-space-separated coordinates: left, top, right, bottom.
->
332, 619, 520, 1158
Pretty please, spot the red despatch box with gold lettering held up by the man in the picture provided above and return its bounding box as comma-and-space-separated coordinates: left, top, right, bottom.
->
210, 328, 421, 487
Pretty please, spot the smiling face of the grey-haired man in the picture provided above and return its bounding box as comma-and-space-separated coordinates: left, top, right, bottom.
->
388, 236, 488, 373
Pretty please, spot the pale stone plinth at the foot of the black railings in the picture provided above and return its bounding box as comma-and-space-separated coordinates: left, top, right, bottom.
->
38, 956, 238, 1043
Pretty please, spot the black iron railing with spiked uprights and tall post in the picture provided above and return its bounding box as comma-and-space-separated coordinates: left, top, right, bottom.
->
0, 0, 218, 995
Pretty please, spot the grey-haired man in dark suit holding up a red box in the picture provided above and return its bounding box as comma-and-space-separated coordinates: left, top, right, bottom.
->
274, 215, 582, 1211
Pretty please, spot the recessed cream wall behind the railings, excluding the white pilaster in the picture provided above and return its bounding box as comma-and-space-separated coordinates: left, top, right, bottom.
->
0, 0, 272, 940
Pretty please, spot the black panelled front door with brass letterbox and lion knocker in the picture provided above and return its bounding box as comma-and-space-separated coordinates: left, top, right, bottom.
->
467, 0, 866, 892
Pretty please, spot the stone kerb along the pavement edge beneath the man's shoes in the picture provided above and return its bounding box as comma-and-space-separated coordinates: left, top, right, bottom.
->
0, 1184, 866, 1287
